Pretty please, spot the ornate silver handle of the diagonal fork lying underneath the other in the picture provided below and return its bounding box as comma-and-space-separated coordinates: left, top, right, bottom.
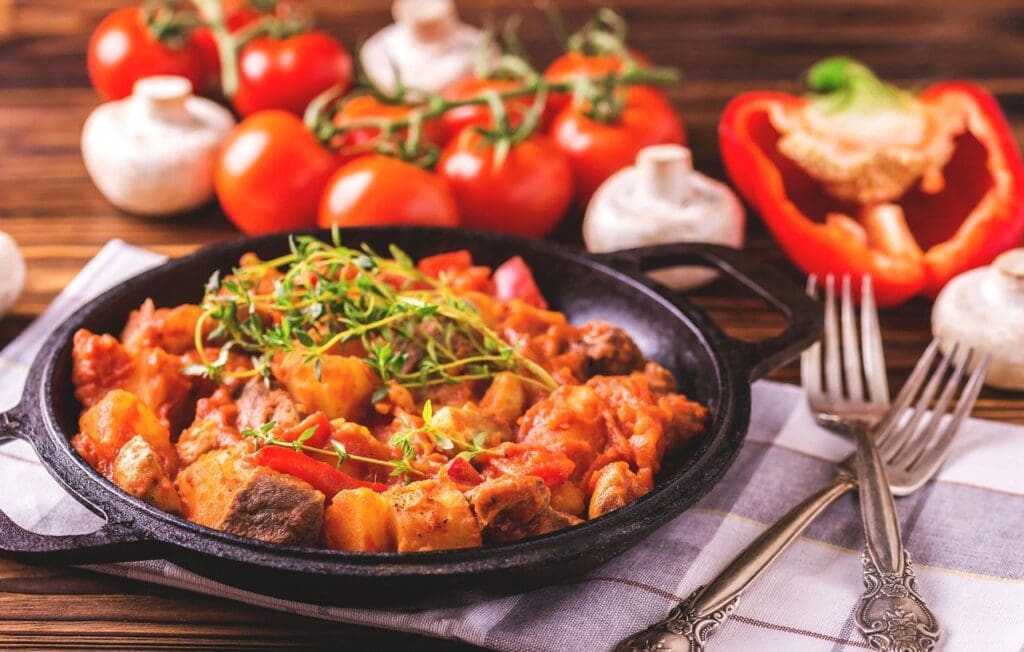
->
615, 473, 856, 652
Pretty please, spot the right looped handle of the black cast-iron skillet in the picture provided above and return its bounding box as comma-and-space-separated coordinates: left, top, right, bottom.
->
598, 243, 822, 380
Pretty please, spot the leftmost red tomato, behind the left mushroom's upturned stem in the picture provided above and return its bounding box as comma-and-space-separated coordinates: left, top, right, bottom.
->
86, 7, 206, 99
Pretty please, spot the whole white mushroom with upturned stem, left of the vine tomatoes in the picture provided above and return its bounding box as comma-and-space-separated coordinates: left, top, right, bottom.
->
82, 76, 234, 216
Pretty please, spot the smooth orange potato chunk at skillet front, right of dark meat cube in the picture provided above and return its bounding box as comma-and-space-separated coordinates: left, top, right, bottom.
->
324, 487, 396, 553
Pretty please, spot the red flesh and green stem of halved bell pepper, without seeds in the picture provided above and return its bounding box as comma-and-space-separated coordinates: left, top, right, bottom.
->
719, 58, 1024, 306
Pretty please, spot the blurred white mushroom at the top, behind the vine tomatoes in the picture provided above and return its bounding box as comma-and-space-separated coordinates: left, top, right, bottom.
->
360, 0, 483, 92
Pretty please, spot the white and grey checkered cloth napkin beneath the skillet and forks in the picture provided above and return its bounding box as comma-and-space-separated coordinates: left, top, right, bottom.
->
0, 241, 1024, 652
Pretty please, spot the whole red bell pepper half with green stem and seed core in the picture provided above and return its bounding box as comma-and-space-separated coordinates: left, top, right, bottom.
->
719, 57, 1024, 306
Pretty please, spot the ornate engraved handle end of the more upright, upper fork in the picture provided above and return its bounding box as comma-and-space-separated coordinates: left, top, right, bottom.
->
854, 550, 939, 652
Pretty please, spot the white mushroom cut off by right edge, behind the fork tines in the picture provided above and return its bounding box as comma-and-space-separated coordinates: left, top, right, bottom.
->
932, 249, 1024, 390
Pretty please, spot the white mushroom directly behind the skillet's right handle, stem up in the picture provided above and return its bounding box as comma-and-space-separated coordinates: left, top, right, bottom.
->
583, 144, 745, 290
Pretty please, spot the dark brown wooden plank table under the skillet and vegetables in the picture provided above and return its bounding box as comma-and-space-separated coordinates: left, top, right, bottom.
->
0, 0, 1024, 649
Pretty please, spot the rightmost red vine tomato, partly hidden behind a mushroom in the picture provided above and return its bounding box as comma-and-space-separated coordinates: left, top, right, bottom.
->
550, 86, 686, 206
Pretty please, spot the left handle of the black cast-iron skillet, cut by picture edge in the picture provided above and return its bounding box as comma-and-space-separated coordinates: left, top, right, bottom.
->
0, 407, 153, 564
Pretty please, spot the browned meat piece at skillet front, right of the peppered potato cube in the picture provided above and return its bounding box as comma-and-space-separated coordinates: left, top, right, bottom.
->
466, 475, 582, 542
